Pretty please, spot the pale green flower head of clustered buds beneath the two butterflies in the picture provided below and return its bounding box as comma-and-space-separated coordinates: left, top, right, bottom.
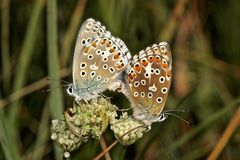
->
51, 98, 148, 156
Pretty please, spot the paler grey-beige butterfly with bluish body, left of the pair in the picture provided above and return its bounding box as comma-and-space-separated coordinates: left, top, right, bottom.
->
66, 18, 131, 103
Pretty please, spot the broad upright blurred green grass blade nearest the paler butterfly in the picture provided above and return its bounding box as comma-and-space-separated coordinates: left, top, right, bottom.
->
47, 0, 63, 159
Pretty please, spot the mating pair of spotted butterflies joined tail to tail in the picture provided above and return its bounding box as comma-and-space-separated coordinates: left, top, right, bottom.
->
67, 18, 172, 124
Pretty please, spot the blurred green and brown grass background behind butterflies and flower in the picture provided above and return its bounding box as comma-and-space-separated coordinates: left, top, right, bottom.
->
0, 0, 240, 160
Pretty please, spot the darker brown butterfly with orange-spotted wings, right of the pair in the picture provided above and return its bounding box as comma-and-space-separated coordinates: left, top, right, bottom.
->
125, 42, 172, 125
